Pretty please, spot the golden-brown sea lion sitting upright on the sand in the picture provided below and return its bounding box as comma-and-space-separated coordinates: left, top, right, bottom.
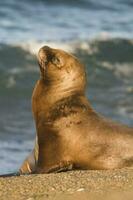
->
20, 46, 133, 173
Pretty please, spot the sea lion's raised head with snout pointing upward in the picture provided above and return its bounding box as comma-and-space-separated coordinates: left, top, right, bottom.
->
38, 46, 86, 92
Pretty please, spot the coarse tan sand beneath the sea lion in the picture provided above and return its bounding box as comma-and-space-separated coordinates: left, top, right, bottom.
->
0, 168, 133, 200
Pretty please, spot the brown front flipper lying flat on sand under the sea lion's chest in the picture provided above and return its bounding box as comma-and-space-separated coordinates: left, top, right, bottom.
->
46, 161, 73, 173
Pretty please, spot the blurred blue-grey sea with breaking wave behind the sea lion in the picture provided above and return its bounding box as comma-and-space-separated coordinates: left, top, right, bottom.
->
0, 0, 133, 174
